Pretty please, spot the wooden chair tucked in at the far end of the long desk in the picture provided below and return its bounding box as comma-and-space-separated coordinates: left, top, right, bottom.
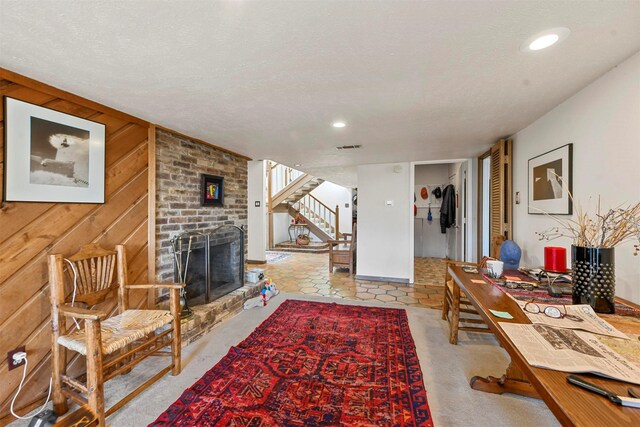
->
442, 258, 491, 345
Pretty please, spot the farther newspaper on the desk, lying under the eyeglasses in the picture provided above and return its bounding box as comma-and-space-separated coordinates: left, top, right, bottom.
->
516, 300, 629, 339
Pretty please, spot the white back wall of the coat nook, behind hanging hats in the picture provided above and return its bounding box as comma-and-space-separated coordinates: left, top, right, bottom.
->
411, 164, 449, 258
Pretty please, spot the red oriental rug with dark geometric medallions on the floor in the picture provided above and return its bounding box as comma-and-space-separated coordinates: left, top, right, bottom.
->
150, 300, 433, 427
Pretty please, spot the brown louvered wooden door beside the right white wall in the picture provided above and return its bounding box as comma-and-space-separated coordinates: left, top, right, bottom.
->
489, 139, 513, 258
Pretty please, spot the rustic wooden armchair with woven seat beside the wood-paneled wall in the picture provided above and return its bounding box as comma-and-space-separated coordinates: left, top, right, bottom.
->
48, 244, 184, 426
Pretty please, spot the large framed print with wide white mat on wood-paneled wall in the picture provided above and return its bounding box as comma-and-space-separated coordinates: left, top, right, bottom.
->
3, 96, 105, 203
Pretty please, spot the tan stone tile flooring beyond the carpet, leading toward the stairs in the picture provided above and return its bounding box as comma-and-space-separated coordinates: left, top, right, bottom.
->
247, 253, 444, 309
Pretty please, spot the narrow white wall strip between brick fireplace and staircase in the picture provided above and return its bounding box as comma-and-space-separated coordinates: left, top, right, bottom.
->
247, 160, 267, 261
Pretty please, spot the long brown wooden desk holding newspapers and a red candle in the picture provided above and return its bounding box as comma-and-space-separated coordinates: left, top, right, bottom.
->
449, 266, 640, 426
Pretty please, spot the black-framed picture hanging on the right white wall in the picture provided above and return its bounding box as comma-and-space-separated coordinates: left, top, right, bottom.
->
527, 144, 573, 215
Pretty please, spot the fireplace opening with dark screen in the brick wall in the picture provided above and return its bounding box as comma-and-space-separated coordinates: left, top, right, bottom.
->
171, 225, 244, 307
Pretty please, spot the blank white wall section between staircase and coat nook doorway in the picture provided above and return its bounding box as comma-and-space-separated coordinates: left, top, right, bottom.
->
357, 163, 413, 281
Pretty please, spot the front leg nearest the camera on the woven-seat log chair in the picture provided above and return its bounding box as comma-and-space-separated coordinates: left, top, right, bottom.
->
85, 321, 105, 427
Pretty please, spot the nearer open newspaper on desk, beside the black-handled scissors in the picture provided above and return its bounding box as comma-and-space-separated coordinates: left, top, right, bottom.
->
499, 322, 640, 384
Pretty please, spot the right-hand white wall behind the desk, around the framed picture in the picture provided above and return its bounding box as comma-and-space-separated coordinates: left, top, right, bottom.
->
513, 53, 640, 303
